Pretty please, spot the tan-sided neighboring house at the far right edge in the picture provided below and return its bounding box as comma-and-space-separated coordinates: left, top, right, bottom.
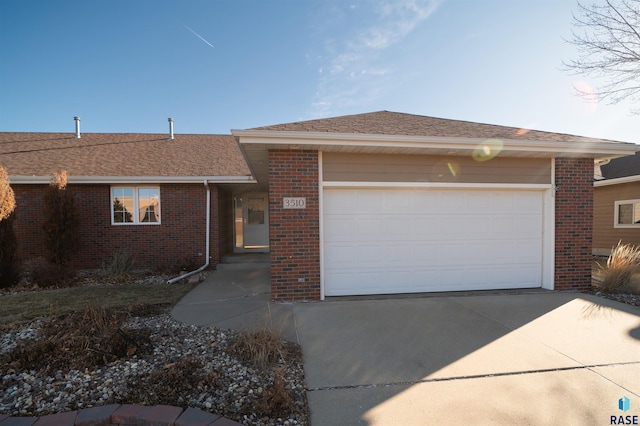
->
593, 153, 640, 256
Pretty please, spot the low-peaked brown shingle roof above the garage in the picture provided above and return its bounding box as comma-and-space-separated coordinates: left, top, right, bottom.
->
251, 111, 614, 142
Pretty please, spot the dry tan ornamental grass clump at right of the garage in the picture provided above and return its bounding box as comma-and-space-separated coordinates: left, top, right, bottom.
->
598, 242, 640, 293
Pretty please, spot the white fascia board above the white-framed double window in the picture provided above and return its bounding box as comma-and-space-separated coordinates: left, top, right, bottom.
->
9, 176, 257, 184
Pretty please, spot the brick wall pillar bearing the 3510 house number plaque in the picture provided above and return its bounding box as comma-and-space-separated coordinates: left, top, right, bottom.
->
269, 150, 320, 301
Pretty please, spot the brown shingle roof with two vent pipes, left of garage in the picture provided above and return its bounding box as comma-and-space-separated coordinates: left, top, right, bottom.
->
0, 133, 250, 177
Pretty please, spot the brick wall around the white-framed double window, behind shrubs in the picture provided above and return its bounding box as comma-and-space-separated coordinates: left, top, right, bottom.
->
12, 184, 221, 269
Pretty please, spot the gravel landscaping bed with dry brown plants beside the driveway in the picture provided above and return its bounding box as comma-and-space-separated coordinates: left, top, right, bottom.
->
0, 308, 309, 425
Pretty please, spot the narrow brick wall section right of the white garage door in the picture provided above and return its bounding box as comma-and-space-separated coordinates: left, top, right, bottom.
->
555, 158, 593, 290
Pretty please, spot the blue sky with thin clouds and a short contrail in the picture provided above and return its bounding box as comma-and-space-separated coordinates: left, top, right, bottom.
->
0, 0, 640, 142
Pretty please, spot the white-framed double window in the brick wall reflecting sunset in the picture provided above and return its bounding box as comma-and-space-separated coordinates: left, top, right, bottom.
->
111, 186, 160, 225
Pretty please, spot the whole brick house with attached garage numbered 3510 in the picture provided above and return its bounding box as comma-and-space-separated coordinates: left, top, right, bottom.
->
0, 111, 640, 301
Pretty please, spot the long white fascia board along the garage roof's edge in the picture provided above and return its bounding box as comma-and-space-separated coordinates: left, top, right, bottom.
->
231, 130, 640, 157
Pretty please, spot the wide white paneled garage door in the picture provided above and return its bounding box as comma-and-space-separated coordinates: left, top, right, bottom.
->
323, 189, 544, 296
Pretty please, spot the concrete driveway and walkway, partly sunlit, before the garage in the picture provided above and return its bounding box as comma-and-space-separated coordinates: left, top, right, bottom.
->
172, 265, 640, 426
